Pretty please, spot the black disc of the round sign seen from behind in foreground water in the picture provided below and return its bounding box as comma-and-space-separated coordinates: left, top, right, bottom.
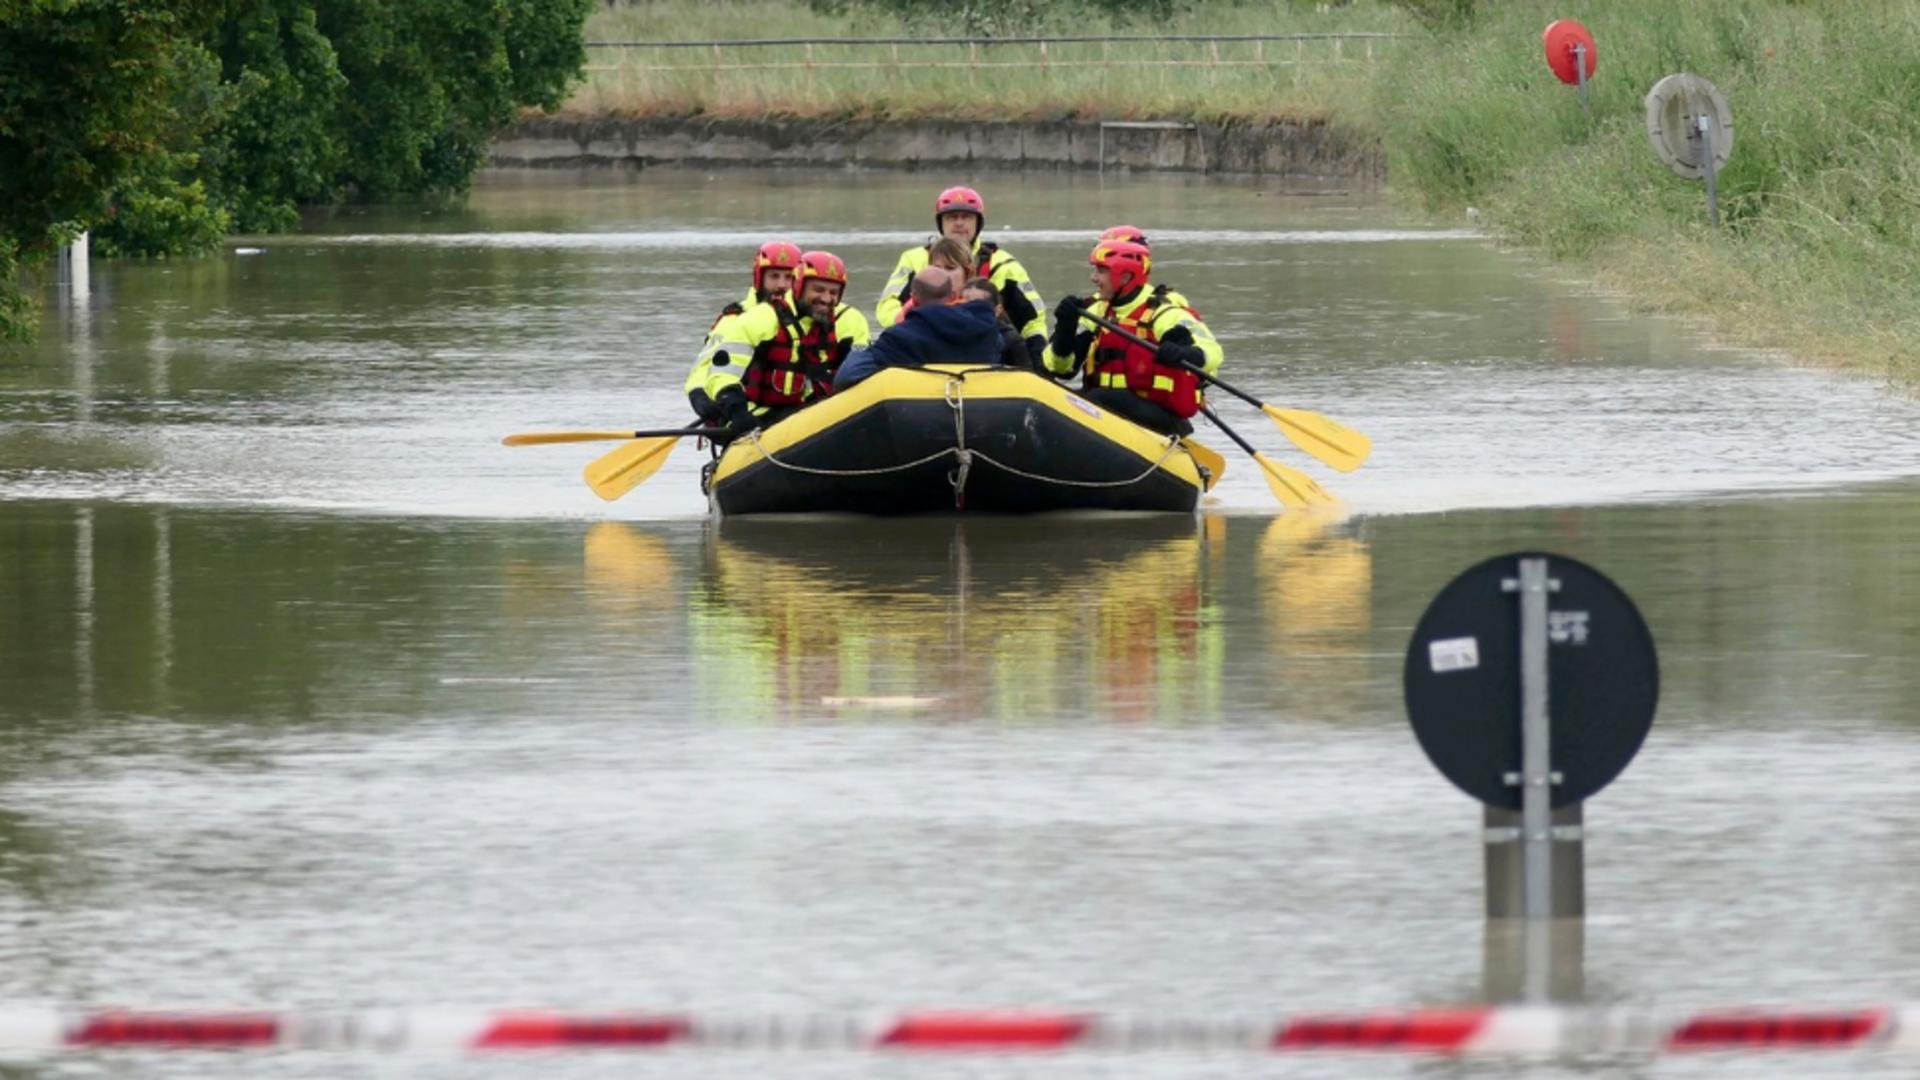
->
1405, 552, 1661, 809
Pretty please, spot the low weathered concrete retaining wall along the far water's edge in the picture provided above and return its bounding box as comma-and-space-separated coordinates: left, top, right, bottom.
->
480, 117, 1384, 181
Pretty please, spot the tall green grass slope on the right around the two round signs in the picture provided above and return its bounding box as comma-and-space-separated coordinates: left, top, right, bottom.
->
1375, 0, 1920, 384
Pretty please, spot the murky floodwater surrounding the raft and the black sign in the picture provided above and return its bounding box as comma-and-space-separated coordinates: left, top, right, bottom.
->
0, 173, 1920, 1078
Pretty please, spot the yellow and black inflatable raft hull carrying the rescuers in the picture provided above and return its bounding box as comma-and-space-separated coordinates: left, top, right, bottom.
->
712, 365, 1204, 515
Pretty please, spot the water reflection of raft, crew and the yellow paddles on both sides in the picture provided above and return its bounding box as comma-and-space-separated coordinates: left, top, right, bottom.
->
586, 513, 1375, 724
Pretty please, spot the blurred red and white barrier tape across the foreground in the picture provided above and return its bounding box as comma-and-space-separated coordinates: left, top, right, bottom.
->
0, 1005, 1920, 1057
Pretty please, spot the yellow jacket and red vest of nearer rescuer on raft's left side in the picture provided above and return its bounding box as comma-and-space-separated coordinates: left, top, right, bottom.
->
685, 296, 872, 411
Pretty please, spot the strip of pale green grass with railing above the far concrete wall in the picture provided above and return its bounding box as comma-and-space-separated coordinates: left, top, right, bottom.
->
566, 0, 1415, 121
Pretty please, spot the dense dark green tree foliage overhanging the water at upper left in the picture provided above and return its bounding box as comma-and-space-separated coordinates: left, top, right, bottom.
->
0, 0, 593, 338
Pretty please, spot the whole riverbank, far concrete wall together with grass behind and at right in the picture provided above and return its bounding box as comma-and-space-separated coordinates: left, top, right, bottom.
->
518, 0, 1920, 386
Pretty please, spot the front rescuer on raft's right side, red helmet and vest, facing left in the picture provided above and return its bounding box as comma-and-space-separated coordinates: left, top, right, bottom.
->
1046, 240, 1223, 434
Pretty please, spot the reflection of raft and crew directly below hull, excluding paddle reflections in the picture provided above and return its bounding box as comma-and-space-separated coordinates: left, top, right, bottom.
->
689, 515, 1225, 721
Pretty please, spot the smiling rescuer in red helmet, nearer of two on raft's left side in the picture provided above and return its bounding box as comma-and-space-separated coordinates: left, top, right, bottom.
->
687, 252, 872, 440
